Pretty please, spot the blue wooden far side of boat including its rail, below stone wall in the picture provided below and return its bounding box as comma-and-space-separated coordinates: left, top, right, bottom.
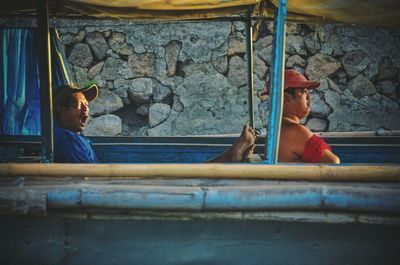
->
0, 136, 400, 163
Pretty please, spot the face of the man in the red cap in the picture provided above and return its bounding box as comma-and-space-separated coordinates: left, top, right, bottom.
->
285, 88, 311, 119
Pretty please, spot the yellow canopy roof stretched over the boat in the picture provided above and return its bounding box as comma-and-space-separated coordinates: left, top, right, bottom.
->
0, 0, 400, 27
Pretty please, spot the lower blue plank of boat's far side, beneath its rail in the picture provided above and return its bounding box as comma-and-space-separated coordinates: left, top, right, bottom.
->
94, 144, 400, 163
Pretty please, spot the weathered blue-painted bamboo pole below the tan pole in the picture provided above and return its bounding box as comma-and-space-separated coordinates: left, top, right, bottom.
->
0, 179, 400, 216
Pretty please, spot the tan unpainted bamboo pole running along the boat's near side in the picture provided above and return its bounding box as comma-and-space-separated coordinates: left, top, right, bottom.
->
0, 163, 400, 182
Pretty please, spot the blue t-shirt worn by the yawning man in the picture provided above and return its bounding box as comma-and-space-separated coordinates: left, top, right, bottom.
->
54, 126, 99, 163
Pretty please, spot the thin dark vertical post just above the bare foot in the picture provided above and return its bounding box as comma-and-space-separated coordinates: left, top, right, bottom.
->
246, 6, 255, 128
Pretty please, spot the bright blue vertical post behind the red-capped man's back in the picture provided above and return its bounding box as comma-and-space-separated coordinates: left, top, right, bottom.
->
265, 0, 286, 164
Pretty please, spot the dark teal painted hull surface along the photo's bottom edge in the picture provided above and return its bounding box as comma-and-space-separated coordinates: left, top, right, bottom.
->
0, 217, 400, 265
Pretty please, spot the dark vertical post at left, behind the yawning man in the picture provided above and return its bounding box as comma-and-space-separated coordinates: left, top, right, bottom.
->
36, 0, 54, 163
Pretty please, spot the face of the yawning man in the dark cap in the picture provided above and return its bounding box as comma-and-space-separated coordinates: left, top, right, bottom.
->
59, 93, 89, 132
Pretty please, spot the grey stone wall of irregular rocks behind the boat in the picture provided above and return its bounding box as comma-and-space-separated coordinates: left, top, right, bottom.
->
57, 20, 400, 136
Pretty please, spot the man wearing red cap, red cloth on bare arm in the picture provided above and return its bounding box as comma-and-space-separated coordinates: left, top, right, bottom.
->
263, 70, 340, 164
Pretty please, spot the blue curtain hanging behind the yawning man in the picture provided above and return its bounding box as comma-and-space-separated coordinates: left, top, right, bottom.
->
0, 28, 71, 135
